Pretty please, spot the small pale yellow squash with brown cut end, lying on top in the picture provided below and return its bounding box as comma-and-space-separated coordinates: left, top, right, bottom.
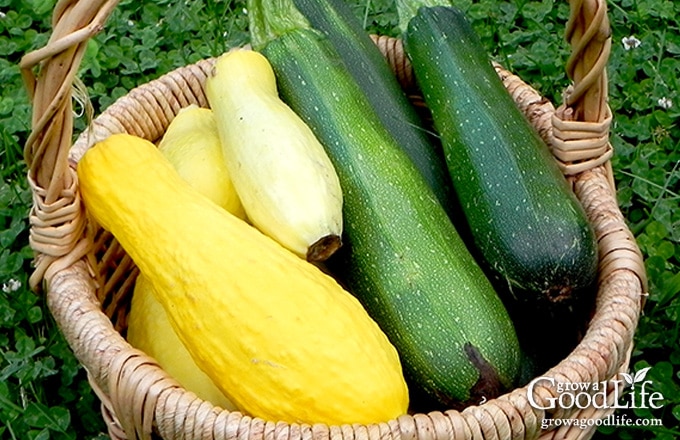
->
205, 49, 342, 261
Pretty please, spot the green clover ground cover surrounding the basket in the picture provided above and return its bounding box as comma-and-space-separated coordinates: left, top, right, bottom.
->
0, 0, 680, 439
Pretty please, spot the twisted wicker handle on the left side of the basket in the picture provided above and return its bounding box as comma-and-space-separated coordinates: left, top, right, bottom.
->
20, 0, 118, 290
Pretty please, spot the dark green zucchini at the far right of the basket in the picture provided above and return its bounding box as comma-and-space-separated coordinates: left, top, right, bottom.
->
398, 0, 598, 308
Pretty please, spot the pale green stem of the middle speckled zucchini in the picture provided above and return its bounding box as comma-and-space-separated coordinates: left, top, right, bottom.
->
247, 0, 311, 50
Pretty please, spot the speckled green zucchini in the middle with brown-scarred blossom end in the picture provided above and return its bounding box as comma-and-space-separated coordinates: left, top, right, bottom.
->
248, 0, 519, 406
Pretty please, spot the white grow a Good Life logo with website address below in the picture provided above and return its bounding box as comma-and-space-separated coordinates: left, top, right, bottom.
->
527, 367, 664, 429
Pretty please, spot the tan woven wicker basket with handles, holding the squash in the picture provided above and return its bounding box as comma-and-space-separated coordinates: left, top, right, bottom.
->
22, 0, 646, 440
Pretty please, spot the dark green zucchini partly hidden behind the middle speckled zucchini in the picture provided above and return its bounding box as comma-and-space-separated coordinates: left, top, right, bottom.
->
295, 0, 458, 216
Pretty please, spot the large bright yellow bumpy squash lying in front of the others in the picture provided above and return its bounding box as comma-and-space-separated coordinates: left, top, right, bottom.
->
78, 135, 408, 425
